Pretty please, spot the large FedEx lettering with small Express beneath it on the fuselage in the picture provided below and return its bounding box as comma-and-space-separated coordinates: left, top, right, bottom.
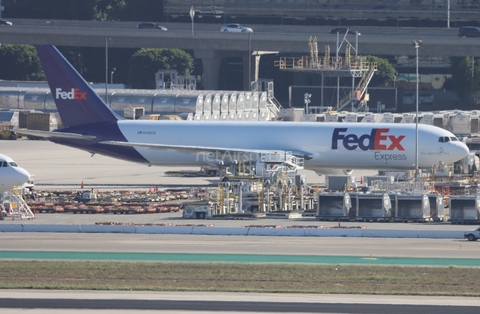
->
332, 128, 407, 162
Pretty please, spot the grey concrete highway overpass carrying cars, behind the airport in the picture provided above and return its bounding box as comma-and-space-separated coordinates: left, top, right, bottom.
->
0, 19, 480, 89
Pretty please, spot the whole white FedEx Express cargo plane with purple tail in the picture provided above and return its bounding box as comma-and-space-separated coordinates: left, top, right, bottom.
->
18, 46, 468, 174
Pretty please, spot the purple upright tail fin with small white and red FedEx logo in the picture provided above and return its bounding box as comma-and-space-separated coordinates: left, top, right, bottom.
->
35, 45, 120, 128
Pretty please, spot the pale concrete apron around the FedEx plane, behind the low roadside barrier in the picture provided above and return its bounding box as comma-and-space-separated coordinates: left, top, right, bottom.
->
0, 139, 473, 231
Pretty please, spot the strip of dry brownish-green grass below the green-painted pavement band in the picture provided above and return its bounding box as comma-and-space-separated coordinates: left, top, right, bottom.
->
0, 261, 480, 297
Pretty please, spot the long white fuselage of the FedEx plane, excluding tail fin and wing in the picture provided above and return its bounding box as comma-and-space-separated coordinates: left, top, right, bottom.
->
58, 120, 468, 170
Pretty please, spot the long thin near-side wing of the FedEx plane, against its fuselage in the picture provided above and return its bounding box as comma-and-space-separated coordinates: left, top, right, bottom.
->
99, 141, 313, 160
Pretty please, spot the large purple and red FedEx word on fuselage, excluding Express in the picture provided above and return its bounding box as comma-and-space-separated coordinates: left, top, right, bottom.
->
332, 128, 405, 151
